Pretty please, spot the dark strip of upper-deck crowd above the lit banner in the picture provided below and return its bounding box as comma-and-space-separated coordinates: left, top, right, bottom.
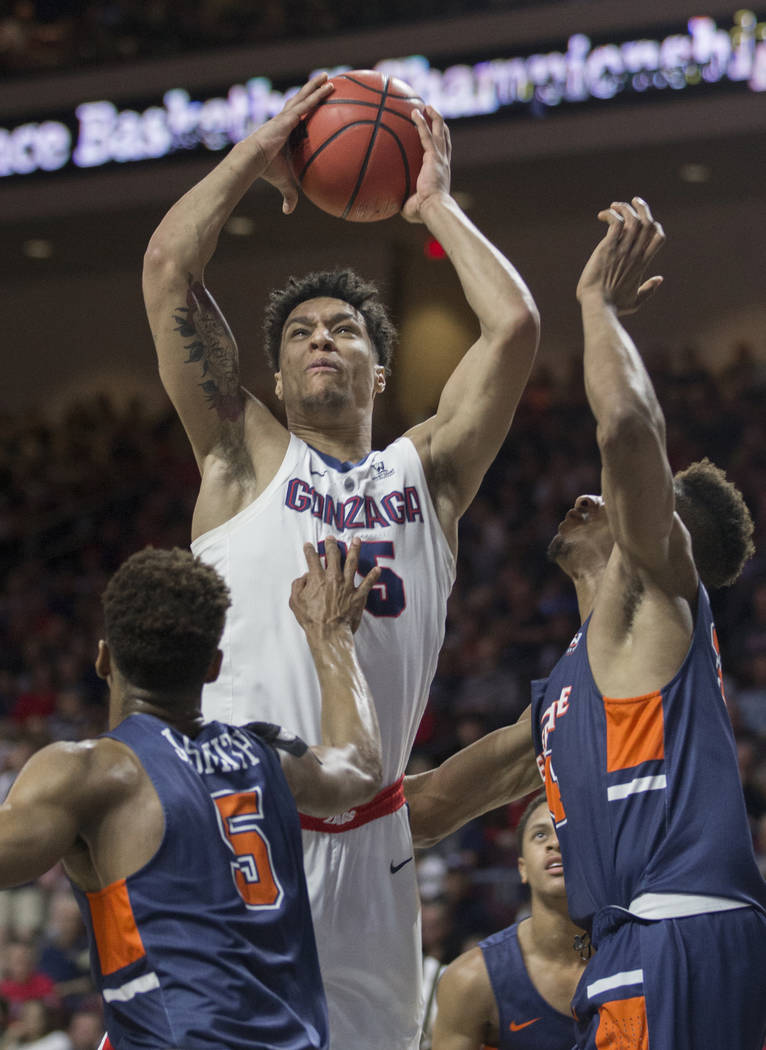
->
0, 0, 532, 75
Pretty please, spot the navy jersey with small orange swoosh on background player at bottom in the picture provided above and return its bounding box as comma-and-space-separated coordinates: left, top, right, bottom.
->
478, 925, 575, 1050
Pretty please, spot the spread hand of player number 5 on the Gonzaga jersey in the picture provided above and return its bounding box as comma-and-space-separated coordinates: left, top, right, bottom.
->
290, 536, 381, 634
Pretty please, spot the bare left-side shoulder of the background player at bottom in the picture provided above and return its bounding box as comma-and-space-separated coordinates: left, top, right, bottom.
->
431, 948, 498, 1050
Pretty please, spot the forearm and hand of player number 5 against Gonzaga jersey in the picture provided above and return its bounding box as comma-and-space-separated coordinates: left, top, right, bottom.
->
282, 537, 383, 817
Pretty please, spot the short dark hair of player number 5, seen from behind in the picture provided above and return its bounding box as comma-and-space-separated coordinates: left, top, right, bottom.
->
102, 547, 231, 690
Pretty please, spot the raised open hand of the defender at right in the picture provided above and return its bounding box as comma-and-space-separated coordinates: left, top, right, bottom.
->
577, 197, 665, 314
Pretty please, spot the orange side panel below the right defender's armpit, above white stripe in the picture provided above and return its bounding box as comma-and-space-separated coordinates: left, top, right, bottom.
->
603, 692, 665, 773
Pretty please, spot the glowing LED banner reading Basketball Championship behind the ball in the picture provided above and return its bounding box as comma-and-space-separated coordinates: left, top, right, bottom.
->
0, 11, 766, 177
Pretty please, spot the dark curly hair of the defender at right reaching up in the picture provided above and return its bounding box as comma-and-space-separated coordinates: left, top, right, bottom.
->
673, 458, 756, 589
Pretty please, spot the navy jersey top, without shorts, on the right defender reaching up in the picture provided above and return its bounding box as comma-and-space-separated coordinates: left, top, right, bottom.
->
532, 584, 766, 926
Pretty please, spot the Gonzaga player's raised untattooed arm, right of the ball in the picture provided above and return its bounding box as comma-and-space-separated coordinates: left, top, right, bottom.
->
402, 107, 539, 541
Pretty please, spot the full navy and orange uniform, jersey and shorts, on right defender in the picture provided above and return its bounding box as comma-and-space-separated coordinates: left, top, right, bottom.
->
532, 584, 766, 1050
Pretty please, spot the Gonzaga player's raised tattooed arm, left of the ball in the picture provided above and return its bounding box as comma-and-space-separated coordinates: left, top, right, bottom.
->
143, 74, 332, 470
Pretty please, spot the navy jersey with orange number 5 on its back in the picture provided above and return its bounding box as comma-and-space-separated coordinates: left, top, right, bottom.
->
75, 714, 327, 1050
